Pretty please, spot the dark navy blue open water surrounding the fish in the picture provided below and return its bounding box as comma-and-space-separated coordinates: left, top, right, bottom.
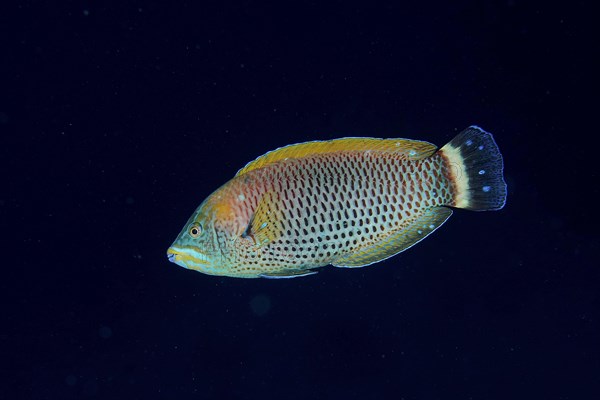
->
0, 0, 600, 399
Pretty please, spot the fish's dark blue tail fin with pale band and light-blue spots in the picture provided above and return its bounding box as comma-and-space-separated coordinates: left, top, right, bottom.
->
439, 126, 506, 211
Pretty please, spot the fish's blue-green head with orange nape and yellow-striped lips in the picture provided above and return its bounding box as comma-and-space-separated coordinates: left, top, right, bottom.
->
167, 190, 244, 276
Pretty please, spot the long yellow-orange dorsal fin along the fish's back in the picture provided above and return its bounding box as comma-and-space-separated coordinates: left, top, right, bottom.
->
235, 138, 437, 176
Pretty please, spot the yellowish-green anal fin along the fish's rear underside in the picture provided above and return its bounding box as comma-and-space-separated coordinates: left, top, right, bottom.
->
332, 207, 452, 268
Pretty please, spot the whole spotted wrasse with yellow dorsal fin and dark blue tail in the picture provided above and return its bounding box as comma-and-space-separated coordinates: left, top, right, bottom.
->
167, 126, 506, 278
